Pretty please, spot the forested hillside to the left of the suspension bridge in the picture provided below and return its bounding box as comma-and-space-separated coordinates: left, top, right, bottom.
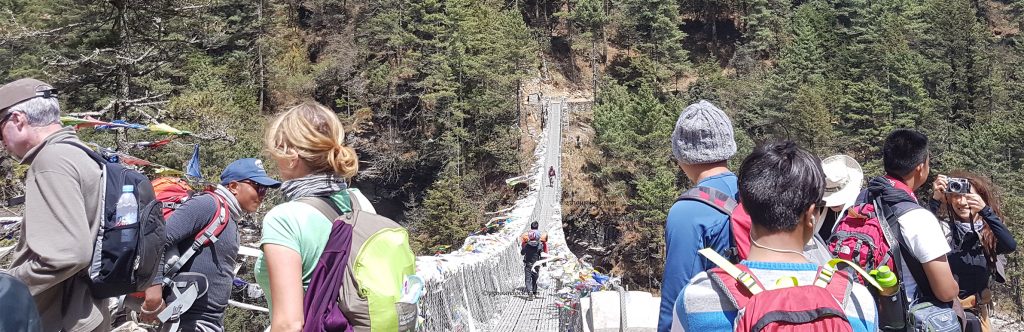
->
0, 0, 539, 257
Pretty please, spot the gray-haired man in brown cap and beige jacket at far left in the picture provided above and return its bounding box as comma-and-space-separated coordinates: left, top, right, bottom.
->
0, 78, 111, 332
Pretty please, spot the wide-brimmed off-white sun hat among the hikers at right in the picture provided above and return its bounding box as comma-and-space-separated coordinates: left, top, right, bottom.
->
821, 155, 864, 207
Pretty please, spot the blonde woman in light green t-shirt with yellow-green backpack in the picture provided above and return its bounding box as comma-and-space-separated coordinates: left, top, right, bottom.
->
255, 102, 416, 331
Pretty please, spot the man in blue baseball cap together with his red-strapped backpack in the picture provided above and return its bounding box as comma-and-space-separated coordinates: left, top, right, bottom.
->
140, 158, 281, 332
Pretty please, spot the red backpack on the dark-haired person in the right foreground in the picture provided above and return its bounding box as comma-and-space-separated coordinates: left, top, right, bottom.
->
699, 249, 853, 332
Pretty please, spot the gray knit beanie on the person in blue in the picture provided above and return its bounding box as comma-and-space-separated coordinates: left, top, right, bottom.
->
672, 100, 736, 165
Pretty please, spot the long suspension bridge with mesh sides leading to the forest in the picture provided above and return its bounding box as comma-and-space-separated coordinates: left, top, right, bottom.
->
417, 98, 578, 331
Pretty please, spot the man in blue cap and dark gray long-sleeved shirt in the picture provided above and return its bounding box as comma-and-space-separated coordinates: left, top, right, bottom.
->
141, 158, 281, 331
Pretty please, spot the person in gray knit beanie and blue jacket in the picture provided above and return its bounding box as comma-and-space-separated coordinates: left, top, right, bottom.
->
657, 100, 739, 332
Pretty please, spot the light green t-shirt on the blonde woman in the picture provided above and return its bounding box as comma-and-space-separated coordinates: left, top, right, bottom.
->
255, 191, 351, 309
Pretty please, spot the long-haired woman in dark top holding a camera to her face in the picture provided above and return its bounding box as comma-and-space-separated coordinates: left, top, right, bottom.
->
930, 171, 1017, 331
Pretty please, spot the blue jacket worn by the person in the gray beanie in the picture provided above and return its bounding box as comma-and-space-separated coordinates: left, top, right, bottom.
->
657, 172, 739, 332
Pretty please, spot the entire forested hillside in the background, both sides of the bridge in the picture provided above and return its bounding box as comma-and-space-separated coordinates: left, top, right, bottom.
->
6, 0, 1024, 323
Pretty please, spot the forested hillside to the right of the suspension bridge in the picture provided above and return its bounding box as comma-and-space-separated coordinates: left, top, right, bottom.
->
559, 0, 1024, 315
